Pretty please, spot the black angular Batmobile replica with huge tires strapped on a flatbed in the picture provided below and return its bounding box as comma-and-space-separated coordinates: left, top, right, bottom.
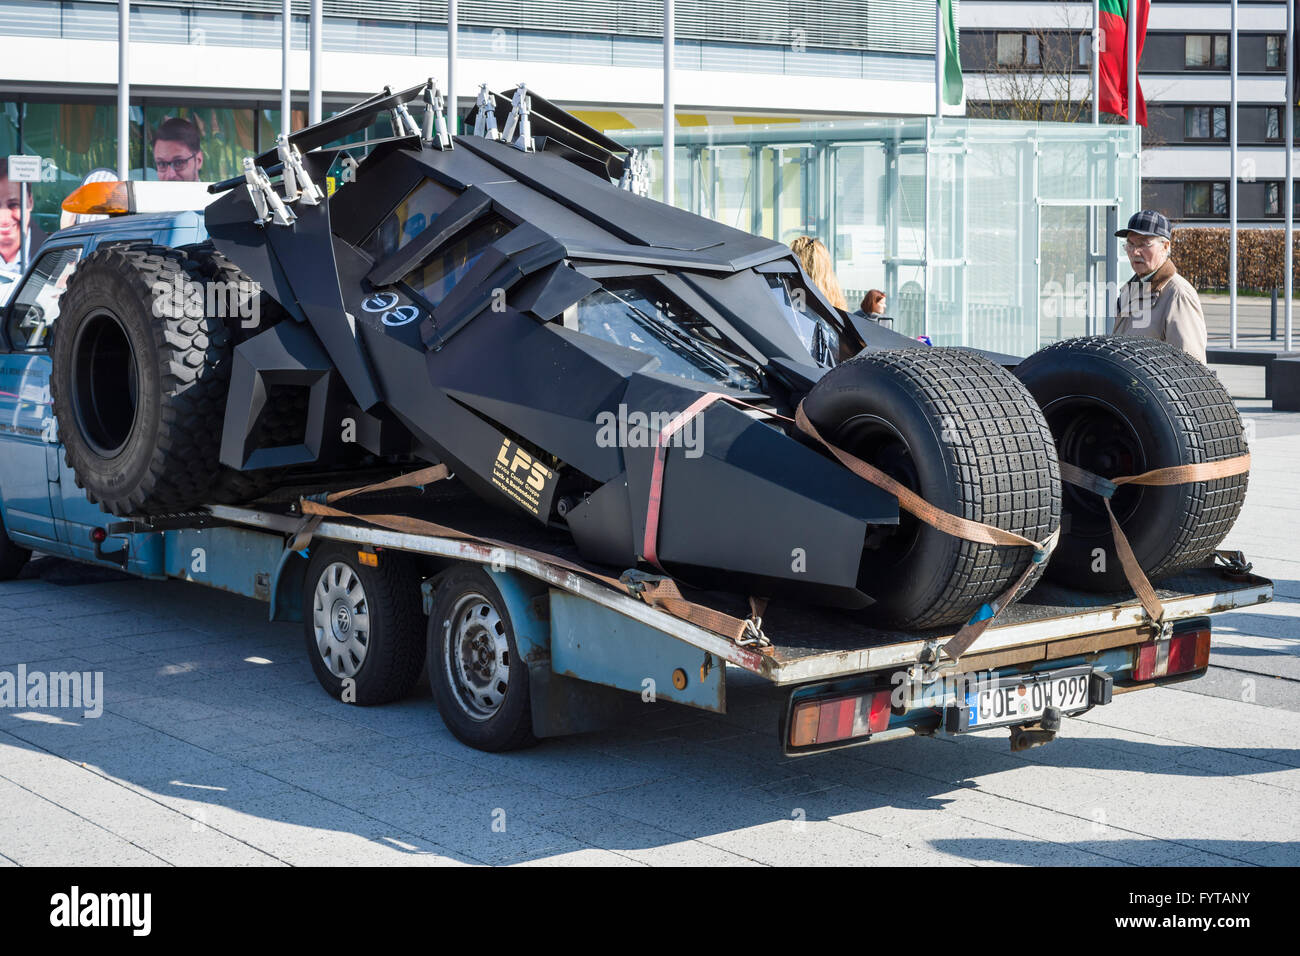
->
52, 82, 1247, 627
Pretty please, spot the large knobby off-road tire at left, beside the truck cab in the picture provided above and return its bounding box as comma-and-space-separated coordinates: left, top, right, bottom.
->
51, 243, 231, 515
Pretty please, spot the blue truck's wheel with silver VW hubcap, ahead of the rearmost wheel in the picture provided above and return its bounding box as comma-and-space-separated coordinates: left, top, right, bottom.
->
303, 542, 424, 706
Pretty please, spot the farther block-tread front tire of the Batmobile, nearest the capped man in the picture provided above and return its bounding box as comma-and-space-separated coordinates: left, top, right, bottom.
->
1015, 336, 1247, 592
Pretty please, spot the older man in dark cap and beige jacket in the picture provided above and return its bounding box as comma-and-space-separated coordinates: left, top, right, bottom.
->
1114, 209, 1205, 362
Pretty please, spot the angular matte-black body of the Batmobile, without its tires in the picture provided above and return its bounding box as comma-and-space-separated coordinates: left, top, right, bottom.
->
207, 91, 910, 607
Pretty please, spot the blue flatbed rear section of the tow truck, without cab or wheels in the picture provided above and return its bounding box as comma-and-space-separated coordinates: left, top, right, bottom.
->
73, 483, 1273, 756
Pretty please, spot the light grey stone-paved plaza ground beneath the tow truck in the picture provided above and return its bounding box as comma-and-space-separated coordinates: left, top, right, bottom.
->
0, 399, 1300, 866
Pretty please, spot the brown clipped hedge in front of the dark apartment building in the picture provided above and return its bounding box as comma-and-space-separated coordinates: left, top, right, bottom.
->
1173, 226, 1300, 293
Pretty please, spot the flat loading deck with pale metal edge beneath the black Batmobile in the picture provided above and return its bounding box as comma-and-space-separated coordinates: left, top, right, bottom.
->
209, 481, 1273, 684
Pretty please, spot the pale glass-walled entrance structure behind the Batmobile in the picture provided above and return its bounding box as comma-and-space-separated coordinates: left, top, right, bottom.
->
616, 117, 1141, 355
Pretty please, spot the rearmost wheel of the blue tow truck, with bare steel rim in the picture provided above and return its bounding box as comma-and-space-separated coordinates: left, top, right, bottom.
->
428, 564, 537, 750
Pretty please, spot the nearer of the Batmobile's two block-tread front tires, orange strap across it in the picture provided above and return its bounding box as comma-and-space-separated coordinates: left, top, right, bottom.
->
803, 349, 1061, 628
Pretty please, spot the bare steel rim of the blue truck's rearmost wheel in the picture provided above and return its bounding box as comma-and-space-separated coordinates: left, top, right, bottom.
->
442, 592, 510, 722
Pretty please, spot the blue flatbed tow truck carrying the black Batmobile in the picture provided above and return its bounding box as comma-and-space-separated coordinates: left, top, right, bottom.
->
0, 200, 1273, 756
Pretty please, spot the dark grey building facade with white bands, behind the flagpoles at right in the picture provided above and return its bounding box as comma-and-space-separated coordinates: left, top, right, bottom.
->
961, 0, 1287, 226
